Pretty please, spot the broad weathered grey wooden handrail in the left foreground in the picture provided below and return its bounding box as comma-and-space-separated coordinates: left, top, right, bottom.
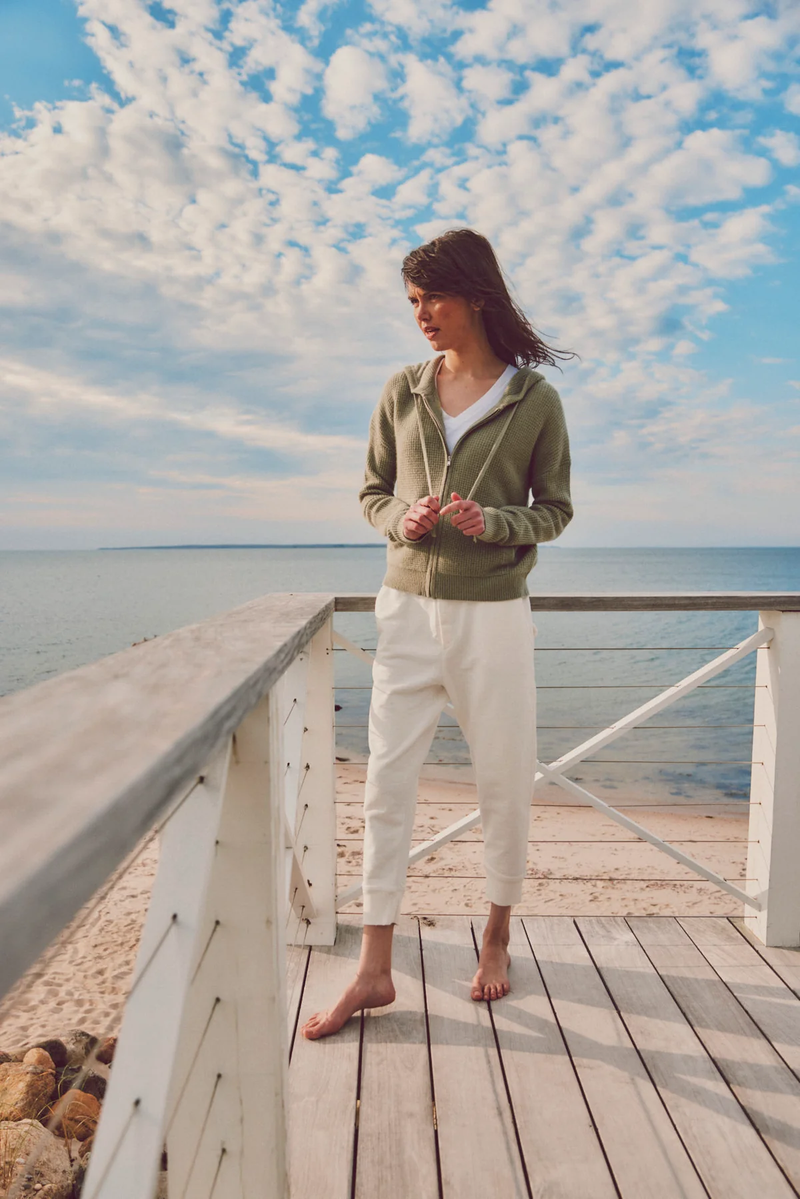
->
0, 594, 333, 994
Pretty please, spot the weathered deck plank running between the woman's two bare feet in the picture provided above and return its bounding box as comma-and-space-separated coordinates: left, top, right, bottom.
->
421, 917, 528, 1199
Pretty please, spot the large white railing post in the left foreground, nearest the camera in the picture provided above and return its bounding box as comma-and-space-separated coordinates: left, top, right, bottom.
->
85, 687, 288, 1199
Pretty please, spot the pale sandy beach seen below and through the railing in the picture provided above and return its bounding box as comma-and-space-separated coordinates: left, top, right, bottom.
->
0, 764, 747, 1052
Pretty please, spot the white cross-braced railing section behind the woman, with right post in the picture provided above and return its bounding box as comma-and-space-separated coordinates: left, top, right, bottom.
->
333, 592, 800, 946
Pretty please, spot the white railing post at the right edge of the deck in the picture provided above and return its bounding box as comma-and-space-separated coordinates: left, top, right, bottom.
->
745, 611, 800, 947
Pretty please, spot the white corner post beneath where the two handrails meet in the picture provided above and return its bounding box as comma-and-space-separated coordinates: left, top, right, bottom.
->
288, 619, 336, 945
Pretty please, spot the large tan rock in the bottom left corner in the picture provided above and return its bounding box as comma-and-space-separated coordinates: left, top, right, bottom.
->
0, 1120, 74, 1199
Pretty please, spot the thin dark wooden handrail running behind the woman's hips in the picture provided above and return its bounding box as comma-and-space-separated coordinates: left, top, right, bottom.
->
336, 591, 800, 611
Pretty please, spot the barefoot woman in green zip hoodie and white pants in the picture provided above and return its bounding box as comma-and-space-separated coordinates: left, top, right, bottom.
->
302, 229, 573, 1040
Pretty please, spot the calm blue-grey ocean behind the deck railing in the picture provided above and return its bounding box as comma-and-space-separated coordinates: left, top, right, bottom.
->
0, 546, 800, 803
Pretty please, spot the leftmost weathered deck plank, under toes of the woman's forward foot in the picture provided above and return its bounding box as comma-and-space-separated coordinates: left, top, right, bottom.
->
288, 917, 361, 1199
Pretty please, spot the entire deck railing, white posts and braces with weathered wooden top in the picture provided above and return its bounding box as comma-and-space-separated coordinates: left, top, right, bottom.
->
0, 592, 800, 1199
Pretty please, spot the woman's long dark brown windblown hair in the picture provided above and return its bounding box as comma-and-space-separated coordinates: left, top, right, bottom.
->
401, 229, 578, 369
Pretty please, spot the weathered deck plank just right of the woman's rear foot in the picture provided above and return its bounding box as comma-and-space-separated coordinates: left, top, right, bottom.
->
475, 920, 616, 1199
